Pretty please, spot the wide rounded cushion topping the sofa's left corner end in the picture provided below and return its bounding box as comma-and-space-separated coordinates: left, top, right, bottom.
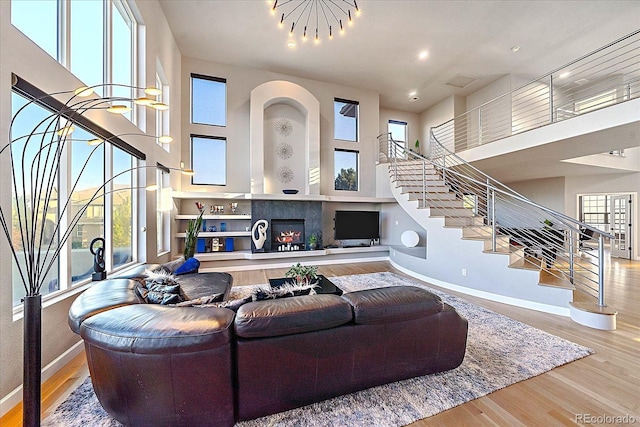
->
80, 304, 234, 354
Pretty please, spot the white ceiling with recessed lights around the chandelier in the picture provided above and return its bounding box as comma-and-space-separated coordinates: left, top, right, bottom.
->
160, 0, 640, 113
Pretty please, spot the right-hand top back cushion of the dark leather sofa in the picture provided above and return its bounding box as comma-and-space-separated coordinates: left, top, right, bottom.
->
342, 286, 444, 325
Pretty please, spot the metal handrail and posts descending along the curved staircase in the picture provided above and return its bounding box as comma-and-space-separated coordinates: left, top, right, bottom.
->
378, 132, 614, 307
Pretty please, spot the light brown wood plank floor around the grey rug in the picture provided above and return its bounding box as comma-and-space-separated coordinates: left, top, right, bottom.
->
0, 259, 640, 427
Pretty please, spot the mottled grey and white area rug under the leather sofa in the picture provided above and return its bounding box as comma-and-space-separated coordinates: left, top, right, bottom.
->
42, 272, 593, 427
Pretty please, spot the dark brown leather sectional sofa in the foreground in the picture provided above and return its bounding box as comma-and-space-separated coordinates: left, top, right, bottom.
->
69, 273, 467, 426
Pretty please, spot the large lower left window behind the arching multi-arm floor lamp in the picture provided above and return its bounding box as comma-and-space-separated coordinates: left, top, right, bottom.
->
11, 88, 137, 306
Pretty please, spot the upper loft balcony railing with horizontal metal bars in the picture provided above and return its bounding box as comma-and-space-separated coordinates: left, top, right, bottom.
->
433, 30, 640, 153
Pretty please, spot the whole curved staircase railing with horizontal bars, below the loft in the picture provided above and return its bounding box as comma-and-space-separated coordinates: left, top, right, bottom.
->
378, 133, 613, 307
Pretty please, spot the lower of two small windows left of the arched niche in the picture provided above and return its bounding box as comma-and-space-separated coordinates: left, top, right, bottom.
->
191, 135, 227, 185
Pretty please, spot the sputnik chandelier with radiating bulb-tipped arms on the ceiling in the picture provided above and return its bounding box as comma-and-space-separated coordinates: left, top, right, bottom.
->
269, 0, 360, 48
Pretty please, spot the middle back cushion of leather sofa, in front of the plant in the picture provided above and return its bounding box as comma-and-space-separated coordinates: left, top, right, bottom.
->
234, 295, 353, 338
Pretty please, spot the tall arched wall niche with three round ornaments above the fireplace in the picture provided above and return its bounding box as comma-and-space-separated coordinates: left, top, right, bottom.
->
249, 80, 320, 195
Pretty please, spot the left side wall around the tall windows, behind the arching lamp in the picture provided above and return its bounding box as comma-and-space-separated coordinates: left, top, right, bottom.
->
0, 1, 181, 404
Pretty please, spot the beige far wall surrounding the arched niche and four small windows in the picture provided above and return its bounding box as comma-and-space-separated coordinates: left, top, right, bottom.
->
181, 57, 380, 197
